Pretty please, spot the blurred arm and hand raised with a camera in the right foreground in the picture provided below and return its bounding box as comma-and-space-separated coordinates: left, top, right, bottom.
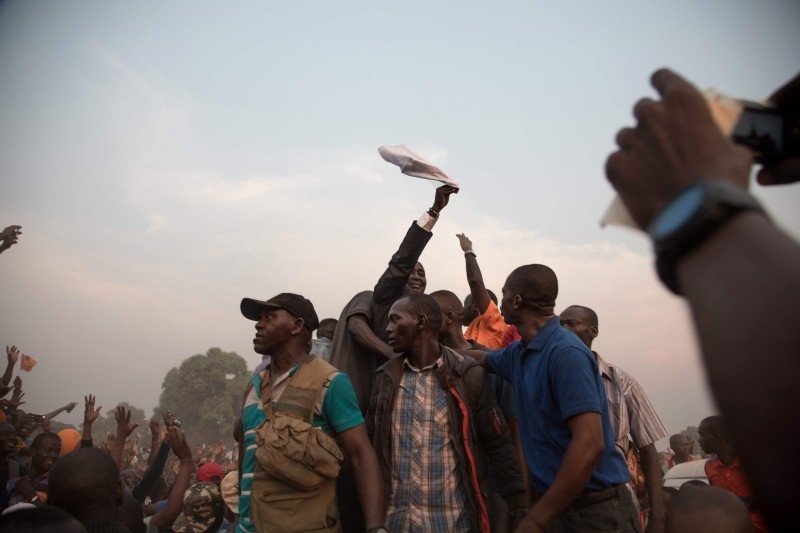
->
606, 70, 800, 529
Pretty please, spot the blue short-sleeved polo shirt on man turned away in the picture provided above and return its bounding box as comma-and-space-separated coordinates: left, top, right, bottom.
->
486, 316, 630, 492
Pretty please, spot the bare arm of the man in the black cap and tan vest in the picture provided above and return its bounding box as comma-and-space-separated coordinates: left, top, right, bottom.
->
339, 424, 385, 529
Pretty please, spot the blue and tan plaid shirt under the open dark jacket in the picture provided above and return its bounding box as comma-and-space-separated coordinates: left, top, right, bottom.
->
386, 357, 469, 533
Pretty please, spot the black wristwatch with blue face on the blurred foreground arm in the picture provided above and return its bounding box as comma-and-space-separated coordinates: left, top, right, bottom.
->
647, 180, 766, 295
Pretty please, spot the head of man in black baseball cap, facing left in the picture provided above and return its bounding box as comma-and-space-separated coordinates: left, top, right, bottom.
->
240, 292, 319, 355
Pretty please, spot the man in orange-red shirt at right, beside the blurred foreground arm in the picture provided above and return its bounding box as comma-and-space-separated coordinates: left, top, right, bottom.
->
698, 415, 769, 533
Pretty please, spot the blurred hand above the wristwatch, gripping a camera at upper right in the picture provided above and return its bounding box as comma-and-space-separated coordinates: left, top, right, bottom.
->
606, 69, 753, 229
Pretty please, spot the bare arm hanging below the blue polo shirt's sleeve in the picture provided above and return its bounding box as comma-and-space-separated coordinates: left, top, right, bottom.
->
516, 413, 605, 532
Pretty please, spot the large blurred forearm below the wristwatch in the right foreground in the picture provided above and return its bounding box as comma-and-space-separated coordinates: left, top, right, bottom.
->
677, 213, 800, 516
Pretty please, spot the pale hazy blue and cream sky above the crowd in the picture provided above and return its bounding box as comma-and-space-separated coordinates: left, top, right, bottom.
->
0, 0, 800, 449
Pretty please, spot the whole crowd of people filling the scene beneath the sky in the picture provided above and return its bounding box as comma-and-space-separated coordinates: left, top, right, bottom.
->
0, 70, 800, 533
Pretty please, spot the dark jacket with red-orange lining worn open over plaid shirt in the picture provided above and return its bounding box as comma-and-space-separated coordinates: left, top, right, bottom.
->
366, 345, 525, 532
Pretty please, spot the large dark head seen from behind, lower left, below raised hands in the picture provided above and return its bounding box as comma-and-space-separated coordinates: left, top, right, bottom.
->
48, 448, 123, 523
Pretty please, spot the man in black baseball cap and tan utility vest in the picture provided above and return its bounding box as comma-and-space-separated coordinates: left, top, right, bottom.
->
237, 293, 384, 533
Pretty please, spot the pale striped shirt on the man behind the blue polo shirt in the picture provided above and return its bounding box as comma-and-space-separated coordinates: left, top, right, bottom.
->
593, 352, 667, 453
